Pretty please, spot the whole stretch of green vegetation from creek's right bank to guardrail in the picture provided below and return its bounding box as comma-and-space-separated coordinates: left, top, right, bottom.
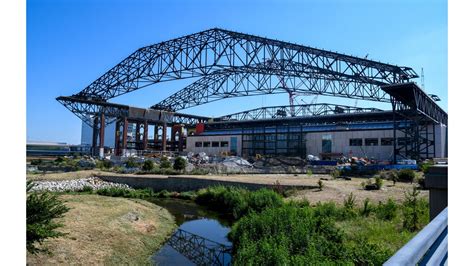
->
229, 190, 428, 265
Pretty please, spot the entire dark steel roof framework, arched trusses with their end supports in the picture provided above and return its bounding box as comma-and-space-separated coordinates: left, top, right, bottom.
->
57, 28, 447, 162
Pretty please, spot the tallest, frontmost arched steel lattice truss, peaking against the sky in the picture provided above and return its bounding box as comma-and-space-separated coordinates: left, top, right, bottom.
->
75, 29, 418, 101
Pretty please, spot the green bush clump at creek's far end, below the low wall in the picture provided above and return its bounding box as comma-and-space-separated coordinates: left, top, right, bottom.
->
196, 186, 283, 219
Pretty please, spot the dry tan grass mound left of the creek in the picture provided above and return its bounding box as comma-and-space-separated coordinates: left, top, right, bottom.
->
27, 195, 176, 265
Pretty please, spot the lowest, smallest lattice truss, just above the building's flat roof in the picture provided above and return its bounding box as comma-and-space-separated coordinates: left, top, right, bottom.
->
214, 103, 382, 121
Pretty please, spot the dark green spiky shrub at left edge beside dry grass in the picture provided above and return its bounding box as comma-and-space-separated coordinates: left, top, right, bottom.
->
26, 181, 69, 254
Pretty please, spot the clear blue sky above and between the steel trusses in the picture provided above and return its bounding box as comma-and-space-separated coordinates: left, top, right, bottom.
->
27, 0, 448, 143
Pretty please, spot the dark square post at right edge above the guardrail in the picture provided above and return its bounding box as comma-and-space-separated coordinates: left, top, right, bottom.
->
425, 165, 448, 221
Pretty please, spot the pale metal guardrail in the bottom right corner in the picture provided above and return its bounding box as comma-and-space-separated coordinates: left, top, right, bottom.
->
383, 207, 448, 266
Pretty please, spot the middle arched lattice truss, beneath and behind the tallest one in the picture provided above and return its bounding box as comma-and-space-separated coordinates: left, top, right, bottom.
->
151, 60, 390, 111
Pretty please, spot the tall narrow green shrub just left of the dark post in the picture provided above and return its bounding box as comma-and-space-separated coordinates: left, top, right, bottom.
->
403, 187, 428, 232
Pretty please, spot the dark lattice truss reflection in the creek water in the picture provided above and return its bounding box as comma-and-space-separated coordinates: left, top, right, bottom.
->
168, 229, 232, 265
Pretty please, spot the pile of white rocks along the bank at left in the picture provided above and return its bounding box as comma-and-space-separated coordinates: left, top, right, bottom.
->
31, 177, 131, 192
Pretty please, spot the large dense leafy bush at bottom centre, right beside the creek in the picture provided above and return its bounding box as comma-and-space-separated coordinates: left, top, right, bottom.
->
229, 205, 345, 265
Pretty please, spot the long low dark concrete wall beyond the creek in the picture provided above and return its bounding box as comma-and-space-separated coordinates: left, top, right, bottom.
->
99, 175, 317, 192
